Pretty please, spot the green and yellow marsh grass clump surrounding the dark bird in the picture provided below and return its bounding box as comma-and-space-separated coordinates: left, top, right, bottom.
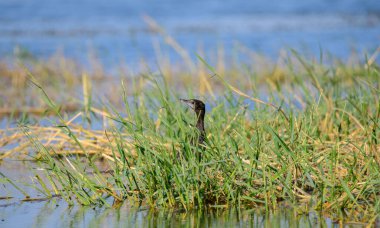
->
0, 47, 380, 223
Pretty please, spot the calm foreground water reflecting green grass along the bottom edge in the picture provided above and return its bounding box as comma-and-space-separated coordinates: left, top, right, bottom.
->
0, 200, 365, 227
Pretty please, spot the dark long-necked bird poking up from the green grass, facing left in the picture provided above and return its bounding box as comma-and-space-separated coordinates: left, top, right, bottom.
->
180, 99, 206, 148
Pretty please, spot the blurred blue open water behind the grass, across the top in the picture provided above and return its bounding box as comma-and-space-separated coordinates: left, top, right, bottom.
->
0, 0, 380, 67
